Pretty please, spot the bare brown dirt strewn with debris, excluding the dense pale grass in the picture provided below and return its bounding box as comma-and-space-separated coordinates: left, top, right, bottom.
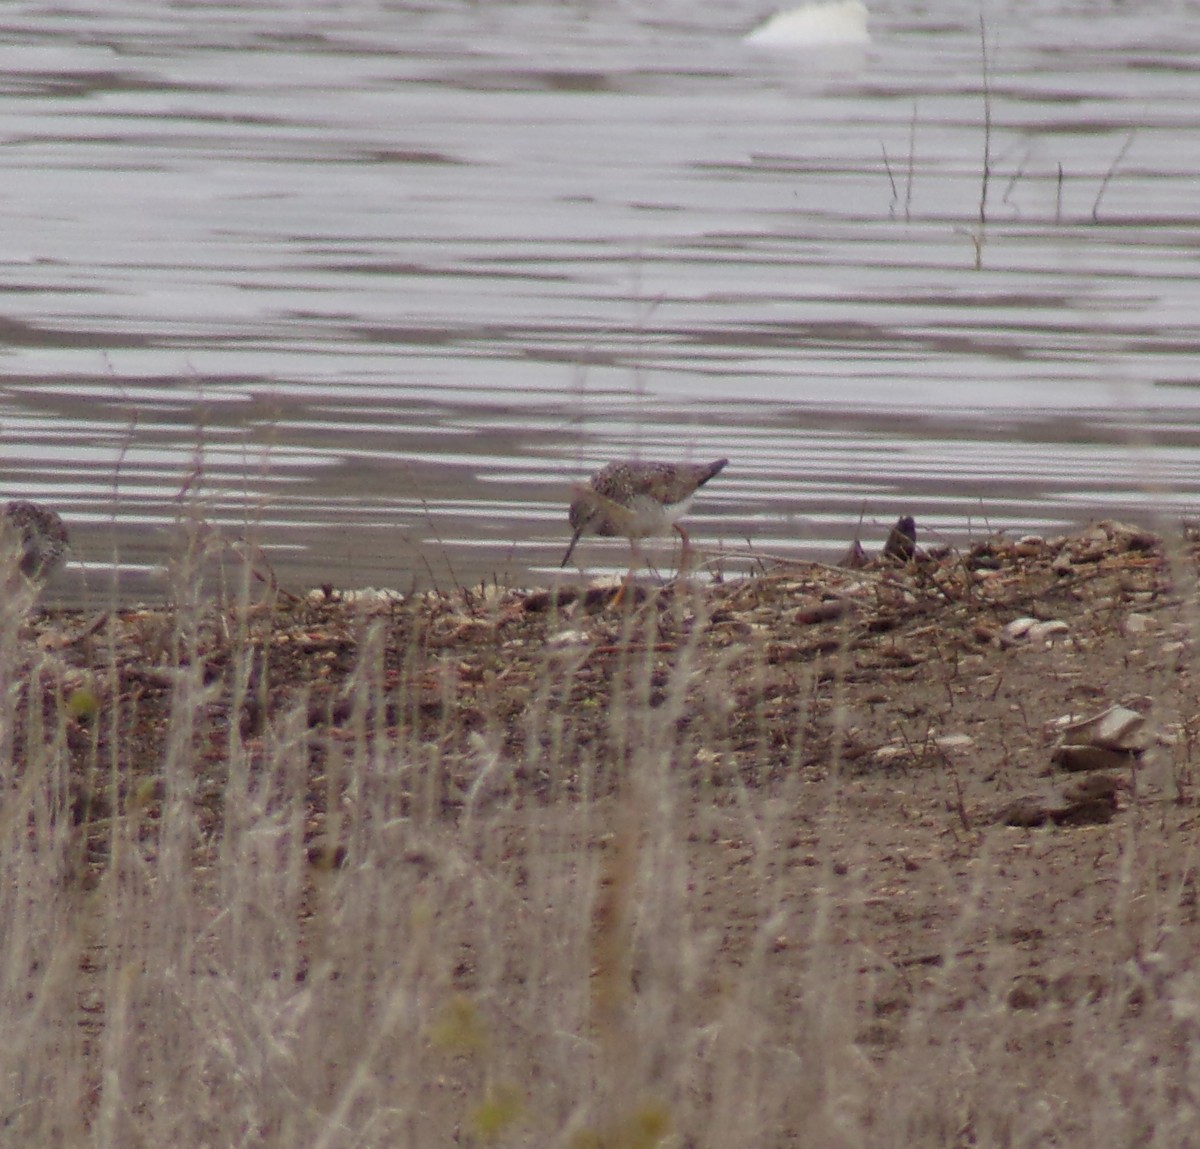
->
23, 524, 1200, 1141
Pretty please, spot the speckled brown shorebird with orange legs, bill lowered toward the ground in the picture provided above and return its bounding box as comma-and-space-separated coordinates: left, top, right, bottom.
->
562, 459, 728, 602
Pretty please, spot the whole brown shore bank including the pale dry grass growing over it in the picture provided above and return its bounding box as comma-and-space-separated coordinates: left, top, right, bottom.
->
5, 523, 1200, 1144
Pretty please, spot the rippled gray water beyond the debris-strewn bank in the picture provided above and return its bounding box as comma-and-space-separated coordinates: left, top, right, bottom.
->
0, 0, 1200, 598
